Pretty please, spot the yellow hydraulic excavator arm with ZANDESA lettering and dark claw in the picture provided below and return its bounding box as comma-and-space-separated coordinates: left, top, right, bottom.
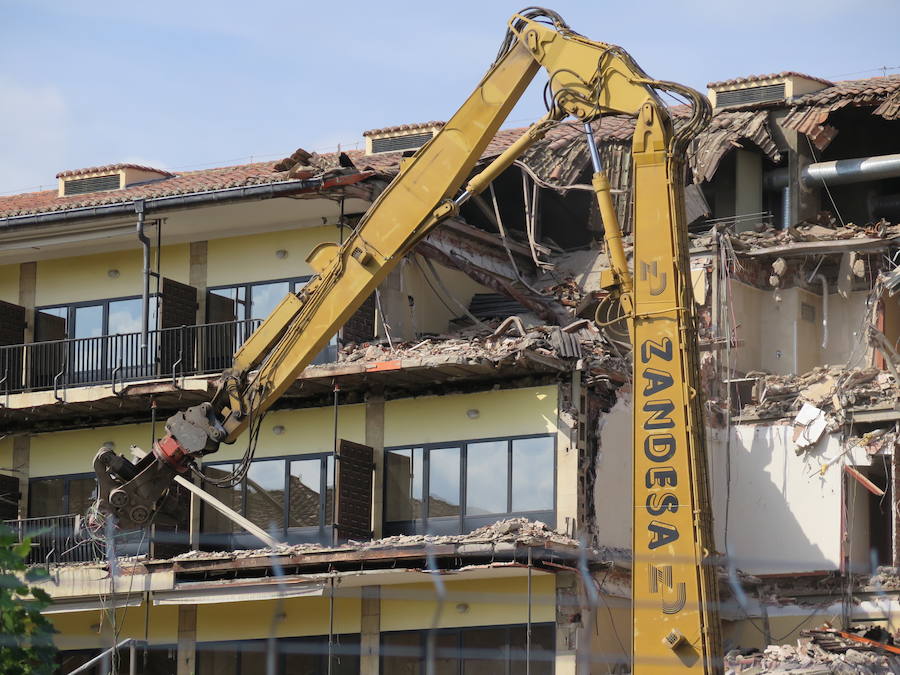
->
95, 8, 720, 673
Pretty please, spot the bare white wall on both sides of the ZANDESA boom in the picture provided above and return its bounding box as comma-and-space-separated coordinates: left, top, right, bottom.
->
594, 400, 869, 574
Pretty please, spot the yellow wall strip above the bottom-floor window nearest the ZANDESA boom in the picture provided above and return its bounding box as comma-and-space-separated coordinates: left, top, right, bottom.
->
381, 575, 556, 632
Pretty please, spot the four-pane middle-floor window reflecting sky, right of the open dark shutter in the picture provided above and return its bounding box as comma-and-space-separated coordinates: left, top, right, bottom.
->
384, 436, 556, 535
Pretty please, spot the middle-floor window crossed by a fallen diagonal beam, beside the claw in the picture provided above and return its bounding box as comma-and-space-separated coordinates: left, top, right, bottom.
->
202, 453, 334, 547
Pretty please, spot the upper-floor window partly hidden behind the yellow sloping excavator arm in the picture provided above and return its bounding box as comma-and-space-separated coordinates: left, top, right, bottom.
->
206, 277, 337, 363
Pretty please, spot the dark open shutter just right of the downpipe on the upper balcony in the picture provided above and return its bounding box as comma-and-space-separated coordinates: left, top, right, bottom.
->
158, 277, 197, 376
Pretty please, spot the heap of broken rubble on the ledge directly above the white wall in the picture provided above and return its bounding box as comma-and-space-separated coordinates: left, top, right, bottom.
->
741, 366, 897, 418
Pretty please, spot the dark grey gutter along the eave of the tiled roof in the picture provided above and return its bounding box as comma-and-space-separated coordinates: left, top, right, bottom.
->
0, 171, 375, 231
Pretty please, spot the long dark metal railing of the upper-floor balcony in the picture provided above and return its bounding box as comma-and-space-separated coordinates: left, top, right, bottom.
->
0, 319, 261, 396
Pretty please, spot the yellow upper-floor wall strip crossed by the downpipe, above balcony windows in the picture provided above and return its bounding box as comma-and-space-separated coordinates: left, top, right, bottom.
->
35, 244, 190, 307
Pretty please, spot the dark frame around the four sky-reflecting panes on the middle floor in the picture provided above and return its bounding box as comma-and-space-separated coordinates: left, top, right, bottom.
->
381, 433, 559, 536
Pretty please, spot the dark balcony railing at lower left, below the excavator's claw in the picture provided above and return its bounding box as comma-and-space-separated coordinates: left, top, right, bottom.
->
4, 514, 104, 565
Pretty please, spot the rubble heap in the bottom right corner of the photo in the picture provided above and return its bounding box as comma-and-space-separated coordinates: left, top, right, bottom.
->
725, 637, 900, 675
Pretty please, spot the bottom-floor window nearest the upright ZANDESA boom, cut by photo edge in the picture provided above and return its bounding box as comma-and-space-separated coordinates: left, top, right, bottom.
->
381, 623, 556, 675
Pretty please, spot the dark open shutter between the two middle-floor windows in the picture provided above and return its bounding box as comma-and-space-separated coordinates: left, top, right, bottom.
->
335, 439, 375, 541
